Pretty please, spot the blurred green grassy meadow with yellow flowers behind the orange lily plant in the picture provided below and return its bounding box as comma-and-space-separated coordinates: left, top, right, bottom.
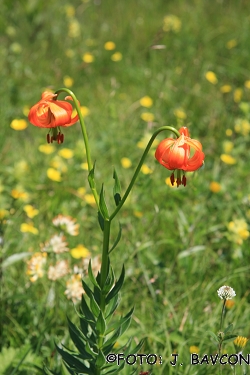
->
0, 0, 250, 375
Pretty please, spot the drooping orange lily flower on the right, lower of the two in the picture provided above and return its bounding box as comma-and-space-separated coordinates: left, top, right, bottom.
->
155, 127, 205, 187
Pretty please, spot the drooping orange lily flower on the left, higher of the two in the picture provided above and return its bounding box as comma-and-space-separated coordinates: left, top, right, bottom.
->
28, 91, 78, 143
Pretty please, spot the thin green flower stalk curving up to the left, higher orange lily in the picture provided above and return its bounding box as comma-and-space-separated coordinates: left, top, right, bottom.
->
55, 88, 99, 209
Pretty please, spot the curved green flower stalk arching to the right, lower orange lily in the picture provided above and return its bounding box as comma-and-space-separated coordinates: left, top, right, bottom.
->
109, 126, 180, 221
